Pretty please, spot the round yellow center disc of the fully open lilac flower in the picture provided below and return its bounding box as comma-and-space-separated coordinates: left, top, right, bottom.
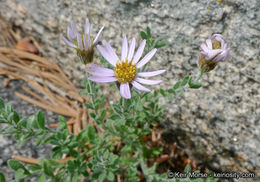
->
115, 58, 136, 83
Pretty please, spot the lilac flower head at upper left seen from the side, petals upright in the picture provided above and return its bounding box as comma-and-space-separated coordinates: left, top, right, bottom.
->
61, 18, 104, 64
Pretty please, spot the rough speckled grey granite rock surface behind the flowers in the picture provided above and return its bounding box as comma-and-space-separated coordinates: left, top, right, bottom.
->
0, 0, 260, 181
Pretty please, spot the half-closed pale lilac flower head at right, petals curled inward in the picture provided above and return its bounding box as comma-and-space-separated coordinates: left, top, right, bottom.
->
199, 34, 229, 72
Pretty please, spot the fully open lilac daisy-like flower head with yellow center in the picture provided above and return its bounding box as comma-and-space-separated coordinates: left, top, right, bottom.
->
87, 37, 165, 99
